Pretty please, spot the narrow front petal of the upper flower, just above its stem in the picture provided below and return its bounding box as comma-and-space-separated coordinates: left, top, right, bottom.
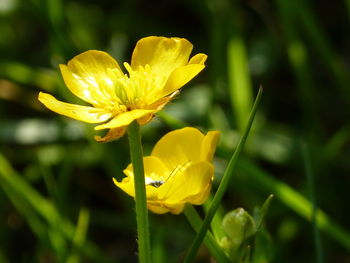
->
95, 109, 154, 130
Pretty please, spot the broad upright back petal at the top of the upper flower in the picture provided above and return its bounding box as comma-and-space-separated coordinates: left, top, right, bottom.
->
131, 36, 193, 76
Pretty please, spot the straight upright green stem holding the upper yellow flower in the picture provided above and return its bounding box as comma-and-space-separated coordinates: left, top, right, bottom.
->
128, 121, 151, 263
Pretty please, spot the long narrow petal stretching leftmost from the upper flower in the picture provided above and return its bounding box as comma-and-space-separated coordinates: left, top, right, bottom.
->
38, 92, 112, 123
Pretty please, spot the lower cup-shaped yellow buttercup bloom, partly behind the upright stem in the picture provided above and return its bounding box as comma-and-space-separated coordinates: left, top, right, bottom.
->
113, 127, 219, 214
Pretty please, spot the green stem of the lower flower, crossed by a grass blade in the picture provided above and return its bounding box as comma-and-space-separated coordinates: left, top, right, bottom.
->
184, 205, 230, 263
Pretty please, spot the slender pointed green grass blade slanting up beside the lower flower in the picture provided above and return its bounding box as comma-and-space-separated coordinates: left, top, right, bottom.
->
184, 88, 262, 263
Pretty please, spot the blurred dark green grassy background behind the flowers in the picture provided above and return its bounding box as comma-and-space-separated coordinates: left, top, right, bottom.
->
0, 0, 350, 263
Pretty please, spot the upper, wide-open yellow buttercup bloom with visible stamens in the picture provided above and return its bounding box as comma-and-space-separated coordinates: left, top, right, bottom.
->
39, 36, 207, 142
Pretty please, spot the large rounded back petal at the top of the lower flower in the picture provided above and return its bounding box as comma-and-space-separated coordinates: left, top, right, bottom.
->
152, 127, 204, 169
